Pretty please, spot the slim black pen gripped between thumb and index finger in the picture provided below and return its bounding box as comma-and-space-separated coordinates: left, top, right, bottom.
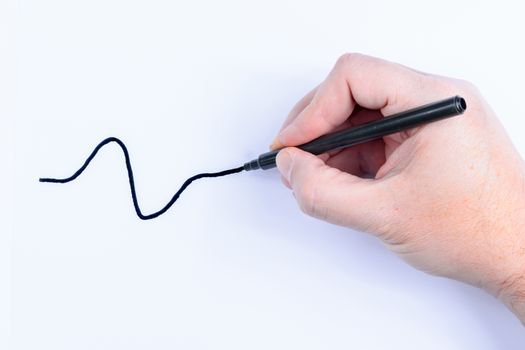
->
252, 96, 467, 170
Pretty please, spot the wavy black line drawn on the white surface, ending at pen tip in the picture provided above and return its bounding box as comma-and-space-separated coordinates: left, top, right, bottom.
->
39, 137, 244, 220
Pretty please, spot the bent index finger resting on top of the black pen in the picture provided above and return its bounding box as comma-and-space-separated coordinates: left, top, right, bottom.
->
278, 54, 435, 146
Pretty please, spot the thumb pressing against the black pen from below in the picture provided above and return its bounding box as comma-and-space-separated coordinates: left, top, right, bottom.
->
277, 147, 395, 233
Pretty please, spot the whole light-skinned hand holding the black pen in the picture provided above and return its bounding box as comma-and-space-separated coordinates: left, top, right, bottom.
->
271, 54, 525, 324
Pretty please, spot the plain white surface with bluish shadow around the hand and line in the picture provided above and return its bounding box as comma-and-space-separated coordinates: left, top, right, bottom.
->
0, 0, 525, 350
